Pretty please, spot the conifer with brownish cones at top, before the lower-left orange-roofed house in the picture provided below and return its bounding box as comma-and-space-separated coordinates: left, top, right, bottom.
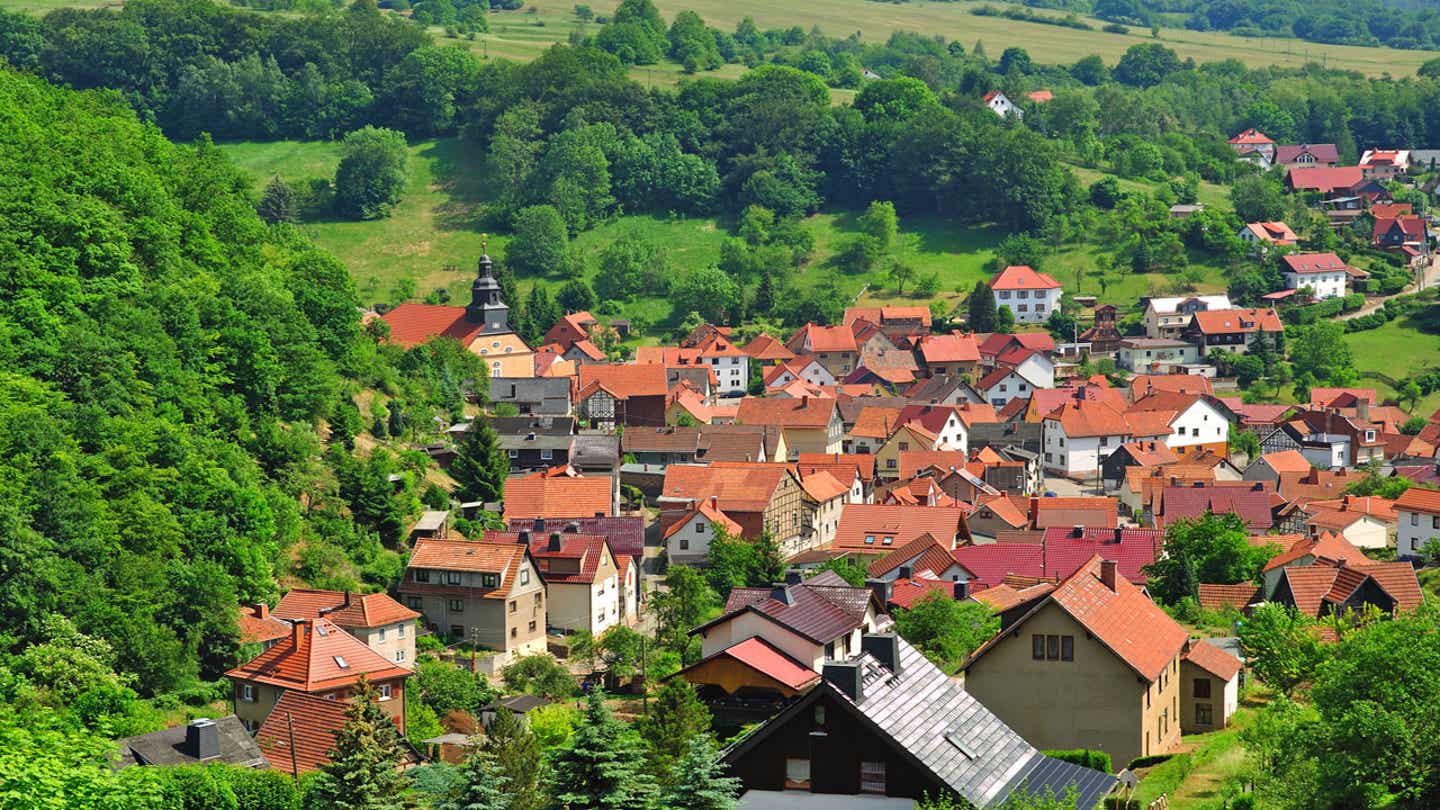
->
305, 676, 418, 810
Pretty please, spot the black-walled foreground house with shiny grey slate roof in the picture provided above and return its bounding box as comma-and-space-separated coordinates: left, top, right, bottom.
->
723, 633, 1116, 810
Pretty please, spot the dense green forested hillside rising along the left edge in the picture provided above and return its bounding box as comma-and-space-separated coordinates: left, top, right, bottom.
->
0, 71, 472, 706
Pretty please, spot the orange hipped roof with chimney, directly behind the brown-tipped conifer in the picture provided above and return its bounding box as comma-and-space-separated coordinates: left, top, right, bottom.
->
225, 618, 412, 692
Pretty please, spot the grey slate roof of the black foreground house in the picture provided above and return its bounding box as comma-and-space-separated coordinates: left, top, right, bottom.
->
726, 638, 1116, 809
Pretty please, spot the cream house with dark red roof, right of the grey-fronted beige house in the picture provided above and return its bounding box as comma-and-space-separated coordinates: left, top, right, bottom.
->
484, 525, 639, 637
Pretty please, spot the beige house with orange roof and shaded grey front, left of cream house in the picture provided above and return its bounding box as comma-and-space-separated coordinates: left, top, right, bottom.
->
399, 540, 546, 662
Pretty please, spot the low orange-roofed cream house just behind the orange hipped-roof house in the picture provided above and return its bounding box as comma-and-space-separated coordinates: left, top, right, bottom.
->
274, 588, 420, 669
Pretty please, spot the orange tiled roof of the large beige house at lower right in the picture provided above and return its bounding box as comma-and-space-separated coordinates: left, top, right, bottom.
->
965, 555, 1189, 682
